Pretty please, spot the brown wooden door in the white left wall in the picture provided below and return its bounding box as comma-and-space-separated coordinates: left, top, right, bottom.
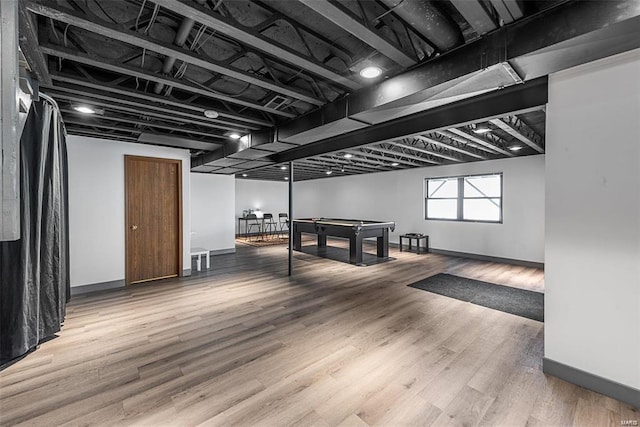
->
125, 156, 182, 284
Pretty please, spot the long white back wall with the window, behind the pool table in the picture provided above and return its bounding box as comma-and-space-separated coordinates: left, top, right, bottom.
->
294, 155, 544, 263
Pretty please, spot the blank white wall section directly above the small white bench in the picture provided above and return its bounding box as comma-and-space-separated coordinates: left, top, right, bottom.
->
191, 173, 236, 251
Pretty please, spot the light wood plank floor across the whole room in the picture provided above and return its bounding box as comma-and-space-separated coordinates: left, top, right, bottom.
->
0, 242, 640, 426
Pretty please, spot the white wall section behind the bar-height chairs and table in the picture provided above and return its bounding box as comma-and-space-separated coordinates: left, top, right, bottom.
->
235, 179, 289, 232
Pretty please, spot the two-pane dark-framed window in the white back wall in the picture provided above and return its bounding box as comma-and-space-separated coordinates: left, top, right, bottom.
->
425, 173, 502, 222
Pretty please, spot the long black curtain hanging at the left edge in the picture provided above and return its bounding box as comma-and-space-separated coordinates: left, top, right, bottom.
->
0, 101, 70, 365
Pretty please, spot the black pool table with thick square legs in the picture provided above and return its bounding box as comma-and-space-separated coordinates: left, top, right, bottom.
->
292, 218, 396, 265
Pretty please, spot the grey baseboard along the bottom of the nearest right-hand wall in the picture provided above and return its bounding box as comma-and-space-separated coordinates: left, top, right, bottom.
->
542, 357, 640, 409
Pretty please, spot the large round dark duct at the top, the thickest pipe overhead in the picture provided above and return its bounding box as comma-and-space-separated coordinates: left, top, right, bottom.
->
382, 0, 464, 51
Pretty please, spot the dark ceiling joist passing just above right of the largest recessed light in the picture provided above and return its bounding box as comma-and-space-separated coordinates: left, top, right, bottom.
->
298, 0, 417, 68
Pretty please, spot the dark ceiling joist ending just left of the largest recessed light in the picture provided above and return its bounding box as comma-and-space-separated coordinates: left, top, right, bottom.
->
153, 0, 362, 91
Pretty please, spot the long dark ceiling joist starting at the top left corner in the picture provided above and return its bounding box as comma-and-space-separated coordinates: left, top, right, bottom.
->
27, 1, 325, 105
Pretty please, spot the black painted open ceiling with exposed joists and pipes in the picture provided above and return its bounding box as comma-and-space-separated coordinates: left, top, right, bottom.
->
20, 0, 637, 180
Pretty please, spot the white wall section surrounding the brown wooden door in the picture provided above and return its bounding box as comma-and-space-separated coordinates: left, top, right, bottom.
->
67, 136, 191, 286
